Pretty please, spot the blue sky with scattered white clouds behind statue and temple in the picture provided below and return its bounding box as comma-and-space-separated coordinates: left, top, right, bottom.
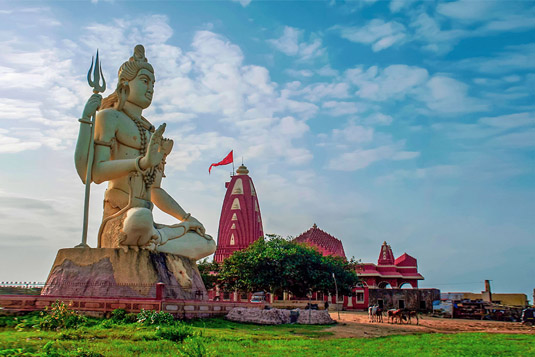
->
0, 0, 535, 300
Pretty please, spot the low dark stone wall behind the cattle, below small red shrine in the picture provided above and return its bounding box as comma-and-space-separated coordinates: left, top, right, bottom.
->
368, 288, 440, 311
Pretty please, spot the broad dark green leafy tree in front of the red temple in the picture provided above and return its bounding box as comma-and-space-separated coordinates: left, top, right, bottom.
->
218, 236, 358, 297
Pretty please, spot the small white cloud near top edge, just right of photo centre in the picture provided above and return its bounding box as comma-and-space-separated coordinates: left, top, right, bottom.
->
267, 26, 325, 60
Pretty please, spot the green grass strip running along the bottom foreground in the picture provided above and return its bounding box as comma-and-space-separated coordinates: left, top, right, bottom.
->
0, 318, 535, 357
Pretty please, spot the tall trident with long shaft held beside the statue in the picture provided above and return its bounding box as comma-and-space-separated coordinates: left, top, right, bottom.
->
75, 49, 106, 248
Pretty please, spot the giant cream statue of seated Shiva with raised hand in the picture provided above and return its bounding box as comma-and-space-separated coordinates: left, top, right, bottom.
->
75, 45, 216, 260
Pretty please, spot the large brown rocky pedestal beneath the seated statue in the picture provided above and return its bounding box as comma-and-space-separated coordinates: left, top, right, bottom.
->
41, 248, 207, 300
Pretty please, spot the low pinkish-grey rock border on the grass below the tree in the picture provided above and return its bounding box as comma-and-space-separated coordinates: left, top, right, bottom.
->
226, 307, 335, 325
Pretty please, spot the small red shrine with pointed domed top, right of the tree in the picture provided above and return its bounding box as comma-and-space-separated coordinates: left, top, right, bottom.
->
357, 242, 424, 288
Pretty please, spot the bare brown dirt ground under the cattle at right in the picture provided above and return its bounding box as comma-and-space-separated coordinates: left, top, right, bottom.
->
325, 311, 535, 338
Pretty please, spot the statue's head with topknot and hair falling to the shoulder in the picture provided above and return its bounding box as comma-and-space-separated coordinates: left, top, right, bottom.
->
101, 45, 154, 110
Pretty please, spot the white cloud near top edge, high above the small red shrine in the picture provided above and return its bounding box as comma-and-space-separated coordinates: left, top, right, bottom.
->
333, 19, 406, 52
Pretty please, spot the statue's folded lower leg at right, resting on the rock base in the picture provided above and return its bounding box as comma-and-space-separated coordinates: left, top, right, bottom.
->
149, 225, 216, 260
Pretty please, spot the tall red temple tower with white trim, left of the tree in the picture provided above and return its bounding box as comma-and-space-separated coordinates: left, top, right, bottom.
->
214, 165, 264, 263
